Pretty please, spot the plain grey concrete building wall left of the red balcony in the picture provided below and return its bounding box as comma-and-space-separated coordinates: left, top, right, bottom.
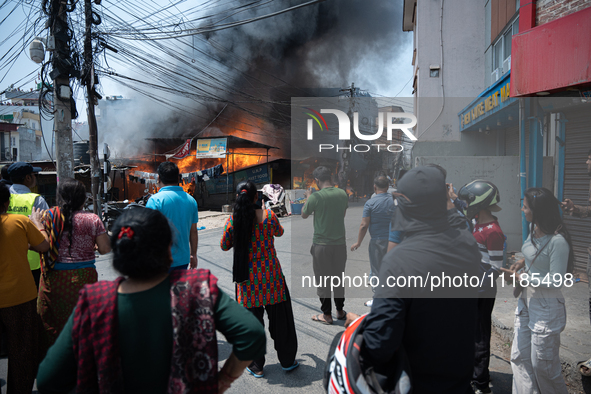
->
403, 0, 521, 251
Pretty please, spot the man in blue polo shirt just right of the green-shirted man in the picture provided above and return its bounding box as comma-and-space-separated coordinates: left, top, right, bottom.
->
351, 175, 396, 306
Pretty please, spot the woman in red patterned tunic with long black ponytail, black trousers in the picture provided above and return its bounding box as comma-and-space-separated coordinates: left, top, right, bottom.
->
221, 181, 299, 378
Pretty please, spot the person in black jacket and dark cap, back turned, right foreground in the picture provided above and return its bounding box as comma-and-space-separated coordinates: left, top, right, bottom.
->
363, 166, 481, 394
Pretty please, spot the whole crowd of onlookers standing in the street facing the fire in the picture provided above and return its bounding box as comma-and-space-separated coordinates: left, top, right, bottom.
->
0, 151, 591, 394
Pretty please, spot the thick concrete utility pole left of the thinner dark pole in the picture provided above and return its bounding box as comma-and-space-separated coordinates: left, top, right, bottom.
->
51, 0, 74, 187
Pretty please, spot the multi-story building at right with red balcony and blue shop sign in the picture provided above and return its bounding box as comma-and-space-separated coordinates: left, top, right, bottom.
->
403, 0, 591, 271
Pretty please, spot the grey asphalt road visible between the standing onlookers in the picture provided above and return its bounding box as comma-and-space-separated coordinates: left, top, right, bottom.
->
0, 203, 511, 394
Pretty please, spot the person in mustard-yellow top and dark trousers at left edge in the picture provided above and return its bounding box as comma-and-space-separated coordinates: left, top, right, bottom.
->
0, 182, 49, 394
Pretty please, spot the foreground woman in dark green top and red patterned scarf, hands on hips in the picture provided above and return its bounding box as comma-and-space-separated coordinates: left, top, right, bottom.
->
37, 208, 266, 394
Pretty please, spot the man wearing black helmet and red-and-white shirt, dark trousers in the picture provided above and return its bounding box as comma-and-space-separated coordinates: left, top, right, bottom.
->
458, 180, 505, 394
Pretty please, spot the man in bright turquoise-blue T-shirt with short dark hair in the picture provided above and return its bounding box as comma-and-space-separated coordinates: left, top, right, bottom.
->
146, 161, 199, 270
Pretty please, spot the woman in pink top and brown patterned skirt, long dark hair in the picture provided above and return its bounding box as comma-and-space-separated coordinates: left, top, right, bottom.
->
37, 178, 111, 346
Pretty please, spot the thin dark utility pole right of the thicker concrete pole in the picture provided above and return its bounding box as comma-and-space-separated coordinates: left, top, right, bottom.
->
84, 0, 101, 216
